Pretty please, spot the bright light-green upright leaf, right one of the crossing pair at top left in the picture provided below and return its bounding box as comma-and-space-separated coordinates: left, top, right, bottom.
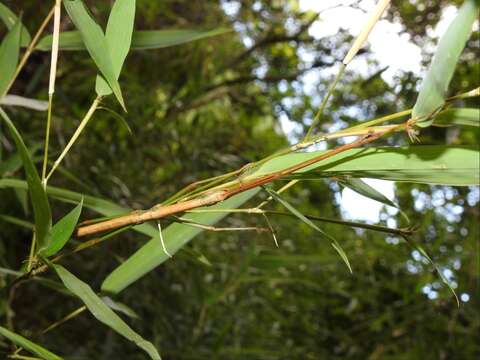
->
95, 0, 135, 96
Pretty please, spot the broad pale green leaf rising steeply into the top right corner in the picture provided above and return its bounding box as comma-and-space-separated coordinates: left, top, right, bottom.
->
412, 0, 480, 127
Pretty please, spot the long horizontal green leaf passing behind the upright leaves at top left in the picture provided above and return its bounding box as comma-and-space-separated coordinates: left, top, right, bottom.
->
36, 28, 231, 51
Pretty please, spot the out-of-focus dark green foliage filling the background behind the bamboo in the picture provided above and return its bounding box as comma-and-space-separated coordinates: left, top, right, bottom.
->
0, 0, 480, 359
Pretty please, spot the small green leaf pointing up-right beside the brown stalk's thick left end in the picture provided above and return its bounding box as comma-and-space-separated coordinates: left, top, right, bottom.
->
40, 199, 83, 257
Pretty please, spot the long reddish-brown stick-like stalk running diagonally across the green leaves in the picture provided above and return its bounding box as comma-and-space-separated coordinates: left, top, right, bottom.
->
76, 121, 409, 237
